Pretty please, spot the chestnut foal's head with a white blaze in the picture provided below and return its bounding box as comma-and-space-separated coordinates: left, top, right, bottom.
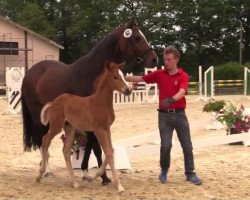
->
106, 62, 132, 95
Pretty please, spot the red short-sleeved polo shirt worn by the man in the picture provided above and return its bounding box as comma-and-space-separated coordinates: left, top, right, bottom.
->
142, 67, 189, 109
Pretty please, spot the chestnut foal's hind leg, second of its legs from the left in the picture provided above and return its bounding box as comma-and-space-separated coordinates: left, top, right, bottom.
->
63, 125, 79, 188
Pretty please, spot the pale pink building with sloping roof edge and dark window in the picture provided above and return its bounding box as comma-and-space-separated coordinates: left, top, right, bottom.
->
0, 16, 63, 86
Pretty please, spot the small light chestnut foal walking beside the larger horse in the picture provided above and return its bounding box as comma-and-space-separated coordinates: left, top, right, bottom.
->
36, 63, 132, 192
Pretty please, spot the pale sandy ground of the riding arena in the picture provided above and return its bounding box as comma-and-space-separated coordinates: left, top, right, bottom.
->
0, 96, 250, 200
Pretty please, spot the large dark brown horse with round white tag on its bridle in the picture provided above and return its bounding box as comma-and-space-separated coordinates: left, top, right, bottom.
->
21, 20, 158, 175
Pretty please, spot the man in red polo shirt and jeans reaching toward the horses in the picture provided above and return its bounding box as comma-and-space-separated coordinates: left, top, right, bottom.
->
126, 46, 202, 185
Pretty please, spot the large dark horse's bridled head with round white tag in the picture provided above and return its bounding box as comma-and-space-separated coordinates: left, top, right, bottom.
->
114, 20, 158, 68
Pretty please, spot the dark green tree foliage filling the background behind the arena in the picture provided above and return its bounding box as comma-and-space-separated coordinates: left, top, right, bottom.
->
0, 0, 250, 77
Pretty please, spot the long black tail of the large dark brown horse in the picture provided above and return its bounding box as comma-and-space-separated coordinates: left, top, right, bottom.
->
21, 96, 33, 151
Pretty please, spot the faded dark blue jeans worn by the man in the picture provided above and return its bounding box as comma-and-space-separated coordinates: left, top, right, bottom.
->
158, 111, 194, 175
